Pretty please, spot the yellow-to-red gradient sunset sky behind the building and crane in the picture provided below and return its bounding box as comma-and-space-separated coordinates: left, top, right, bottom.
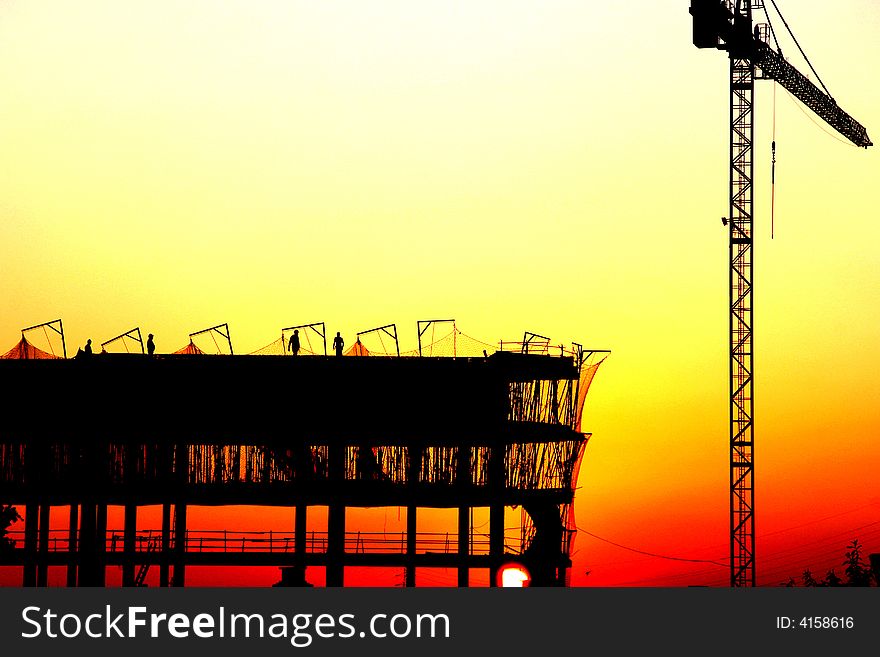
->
0, 0, 880, 586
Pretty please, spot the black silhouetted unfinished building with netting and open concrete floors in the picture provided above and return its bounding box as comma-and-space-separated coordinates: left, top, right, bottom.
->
0, 323, 607, 586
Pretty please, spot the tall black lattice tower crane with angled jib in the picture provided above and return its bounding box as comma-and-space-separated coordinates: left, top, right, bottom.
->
689, 0, 873, 587
